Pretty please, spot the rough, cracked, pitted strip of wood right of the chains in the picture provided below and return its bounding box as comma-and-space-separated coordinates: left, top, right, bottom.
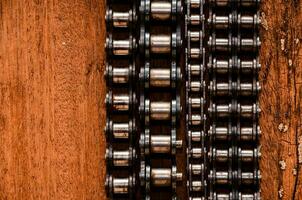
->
260, 0, 302, 199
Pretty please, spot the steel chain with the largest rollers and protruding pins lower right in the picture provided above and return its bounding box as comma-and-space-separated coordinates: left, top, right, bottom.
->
139, 0, 183, 199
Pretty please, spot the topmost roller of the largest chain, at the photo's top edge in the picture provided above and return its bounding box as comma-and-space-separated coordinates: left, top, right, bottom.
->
151, 1, 172, 20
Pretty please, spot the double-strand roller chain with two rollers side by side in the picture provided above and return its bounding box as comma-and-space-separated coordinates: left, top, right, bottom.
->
204, 0, 261, 200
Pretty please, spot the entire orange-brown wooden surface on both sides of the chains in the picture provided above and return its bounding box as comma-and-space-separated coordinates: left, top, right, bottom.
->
0, 0, 302, 200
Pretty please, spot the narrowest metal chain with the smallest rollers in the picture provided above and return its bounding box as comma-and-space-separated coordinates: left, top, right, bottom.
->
185, 0, 207, 199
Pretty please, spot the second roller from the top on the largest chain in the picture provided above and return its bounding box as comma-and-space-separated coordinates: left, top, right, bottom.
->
150, 35, 171, 53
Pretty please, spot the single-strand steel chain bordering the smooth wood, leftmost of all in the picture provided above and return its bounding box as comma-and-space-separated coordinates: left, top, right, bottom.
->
104, 0, 138, 199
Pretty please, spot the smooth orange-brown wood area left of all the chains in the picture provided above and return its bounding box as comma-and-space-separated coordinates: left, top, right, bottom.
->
0, 0, 105, 199
